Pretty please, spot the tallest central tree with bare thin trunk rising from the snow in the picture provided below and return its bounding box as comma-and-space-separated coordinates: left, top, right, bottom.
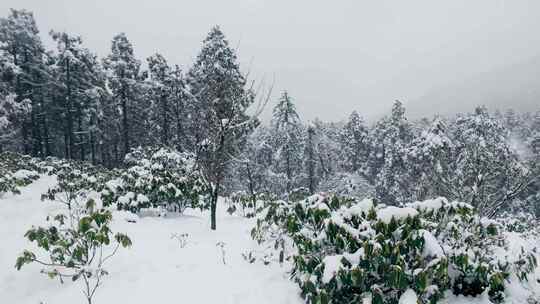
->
187, 26, 258, 230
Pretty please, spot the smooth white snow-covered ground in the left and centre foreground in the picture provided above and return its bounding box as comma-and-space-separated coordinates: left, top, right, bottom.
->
0, 177, 303, 304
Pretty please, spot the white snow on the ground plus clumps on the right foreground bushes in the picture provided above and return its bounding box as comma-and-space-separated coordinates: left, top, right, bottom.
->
0, 176, 540, 304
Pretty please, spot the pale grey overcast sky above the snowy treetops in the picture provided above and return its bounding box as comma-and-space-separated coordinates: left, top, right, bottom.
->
0, 0, 540, 120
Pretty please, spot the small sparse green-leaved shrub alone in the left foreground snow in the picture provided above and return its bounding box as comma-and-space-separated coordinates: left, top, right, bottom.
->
15, 199, 131, 304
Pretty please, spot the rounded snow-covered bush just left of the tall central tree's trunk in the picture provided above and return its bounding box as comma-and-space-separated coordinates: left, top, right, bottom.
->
101, 148, 207, 212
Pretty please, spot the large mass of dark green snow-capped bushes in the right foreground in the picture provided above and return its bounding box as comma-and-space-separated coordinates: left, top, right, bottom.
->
252, 195, 537, 303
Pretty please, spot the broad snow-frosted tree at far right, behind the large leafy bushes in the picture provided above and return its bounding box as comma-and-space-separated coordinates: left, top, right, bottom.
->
452, 107, 535, 216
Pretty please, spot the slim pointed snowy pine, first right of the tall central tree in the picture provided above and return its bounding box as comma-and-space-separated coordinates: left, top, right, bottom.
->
271, 91, 303, 194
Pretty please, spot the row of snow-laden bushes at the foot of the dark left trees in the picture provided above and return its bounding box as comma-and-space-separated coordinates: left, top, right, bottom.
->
4, 148, 208, 213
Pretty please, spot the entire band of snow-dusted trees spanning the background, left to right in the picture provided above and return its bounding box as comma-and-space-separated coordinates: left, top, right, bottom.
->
0, 10, 540, 218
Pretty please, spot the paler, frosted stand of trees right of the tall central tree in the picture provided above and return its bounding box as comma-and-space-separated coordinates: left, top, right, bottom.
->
239, 97, 540, 216
